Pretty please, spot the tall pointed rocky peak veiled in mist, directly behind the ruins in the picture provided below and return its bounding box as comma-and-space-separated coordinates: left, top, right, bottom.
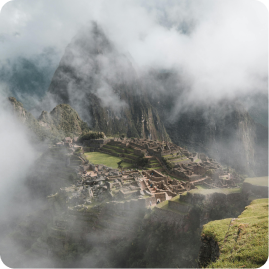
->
49, 24, 168, 139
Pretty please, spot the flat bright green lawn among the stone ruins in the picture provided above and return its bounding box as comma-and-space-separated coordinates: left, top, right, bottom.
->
85, 152, 132, 168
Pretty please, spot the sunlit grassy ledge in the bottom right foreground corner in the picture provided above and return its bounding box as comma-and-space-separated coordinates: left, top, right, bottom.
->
202, 199, 269, 269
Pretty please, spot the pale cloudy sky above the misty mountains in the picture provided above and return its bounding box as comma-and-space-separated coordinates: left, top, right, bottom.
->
0, 0, 269, 105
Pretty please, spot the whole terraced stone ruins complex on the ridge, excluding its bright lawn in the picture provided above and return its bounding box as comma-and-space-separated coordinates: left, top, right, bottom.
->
50, 137, 237, 214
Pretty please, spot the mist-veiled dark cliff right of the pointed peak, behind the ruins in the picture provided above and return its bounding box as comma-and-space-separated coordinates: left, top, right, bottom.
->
163, 104, 256, 172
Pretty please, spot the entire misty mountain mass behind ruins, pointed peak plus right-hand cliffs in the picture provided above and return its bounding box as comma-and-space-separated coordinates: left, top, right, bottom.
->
43, 23, 266, 173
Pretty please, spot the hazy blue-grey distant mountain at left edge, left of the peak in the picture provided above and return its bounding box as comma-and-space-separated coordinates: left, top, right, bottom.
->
0, 48, 59, 109
